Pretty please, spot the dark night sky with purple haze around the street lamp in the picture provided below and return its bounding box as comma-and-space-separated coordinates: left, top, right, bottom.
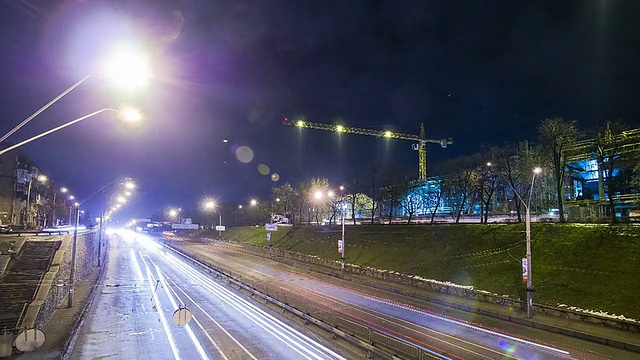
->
0, 0, 640, 217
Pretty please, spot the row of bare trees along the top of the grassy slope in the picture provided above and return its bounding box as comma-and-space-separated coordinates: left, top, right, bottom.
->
262, 118, 640, 224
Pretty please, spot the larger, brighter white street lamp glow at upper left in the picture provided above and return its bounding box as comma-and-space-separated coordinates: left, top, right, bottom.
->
104, 49, 151, 89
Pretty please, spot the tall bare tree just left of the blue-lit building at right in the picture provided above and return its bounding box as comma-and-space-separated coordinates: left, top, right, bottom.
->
538, 118, 579, 222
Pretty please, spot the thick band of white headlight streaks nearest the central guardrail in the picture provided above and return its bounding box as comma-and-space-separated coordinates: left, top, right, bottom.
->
162, 252, 346, 360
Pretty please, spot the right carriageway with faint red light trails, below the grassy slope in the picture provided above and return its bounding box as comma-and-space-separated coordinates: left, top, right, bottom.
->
170, 232, 638, 359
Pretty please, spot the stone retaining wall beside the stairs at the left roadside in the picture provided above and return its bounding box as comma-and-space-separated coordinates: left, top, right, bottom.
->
22, 231, 98, 327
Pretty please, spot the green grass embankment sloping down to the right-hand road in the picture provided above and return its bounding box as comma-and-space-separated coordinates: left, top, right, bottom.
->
195, 224, 640, 320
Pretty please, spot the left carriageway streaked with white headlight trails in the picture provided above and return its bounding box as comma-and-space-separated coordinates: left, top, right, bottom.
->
69, 233, 362, 360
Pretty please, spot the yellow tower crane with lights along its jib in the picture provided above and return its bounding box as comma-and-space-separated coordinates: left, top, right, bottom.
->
283, 118, 453, 181
